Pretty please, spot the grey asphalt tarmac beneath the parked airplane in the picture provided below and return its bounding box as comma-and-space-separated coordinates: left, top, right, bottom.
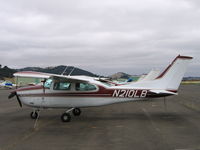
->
0, 85, 200, 150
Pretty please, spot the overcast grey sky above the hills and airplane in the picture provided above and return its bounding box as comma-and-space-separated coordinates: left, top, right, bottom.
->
0, 0, 200, 76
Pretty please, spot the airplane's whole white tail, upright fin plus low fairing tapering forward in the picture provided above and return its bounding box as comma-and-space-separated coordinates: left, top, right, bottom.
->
127, 55, 193, 92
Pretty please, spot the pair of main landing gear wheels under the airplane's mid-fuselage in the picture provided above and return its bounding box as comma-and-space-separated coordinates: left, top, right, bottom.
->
61, 108, 81, 122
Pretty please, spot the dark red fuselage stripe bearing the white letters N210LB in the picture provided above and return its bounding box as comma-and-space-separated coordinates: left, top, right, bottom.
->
16, 85, 177, 98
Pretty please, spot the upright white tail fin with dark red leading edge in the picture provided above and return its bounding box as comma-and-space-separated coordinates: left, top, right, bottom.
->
156, 55, 193, 90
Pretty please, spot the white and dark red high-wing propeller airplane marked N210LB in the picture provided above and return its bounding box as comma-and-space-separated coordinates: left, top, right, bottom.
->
9, 55, 193, 122
